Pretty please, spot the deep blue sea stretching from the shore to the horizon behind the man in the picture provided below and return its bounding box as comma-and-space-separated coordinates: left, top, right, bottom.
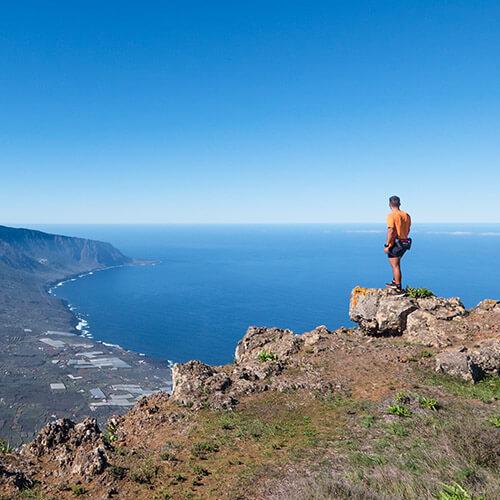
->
31, 224, 500, 364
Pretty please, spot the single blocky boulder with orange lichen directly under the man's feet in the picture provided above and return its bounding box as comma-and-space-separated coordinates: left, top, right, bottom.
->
349, 287, 418, 335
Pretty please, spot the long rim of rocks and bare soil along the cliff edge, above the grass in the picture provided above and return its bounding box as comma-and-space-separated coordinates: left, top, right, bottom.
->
0, 287, 500, 495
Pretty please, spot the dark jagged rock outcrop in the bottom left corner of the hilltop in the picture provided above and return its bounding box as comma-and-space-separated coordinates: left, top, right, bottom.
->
21, 418, 108, 481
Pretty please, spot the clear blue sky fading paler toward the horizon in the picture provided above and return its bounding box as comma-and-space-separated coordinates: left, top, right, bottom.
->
0, 0, 500, 224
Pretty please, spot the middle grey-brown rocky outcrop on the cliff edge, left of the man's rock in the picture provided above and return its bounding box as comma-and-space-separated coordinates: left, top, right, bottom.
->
171, 326, 349, 409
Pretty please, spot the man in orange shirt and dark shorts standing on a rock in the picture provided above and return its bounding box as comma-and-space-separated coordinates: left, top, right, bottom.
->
384, 196, 411, 292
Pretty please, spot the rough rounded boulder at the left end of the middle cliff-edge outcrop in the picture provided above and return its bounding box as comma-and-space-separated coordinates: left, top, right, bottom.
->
172, 361, 235, 409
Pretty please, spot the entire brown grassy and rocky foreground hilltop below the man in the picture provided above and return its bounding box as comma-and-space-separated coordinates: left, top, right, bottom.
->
0, 288, 500, 499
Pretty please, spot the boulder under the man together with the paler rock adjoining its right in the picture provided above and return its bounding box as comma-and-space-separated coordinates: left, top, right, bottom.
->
349, 287, 467, 347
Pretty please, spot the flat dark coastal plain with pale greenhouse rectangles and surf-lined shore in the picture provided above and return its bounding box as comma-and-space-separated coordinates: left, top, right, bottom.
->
0, 262, 172, 446
